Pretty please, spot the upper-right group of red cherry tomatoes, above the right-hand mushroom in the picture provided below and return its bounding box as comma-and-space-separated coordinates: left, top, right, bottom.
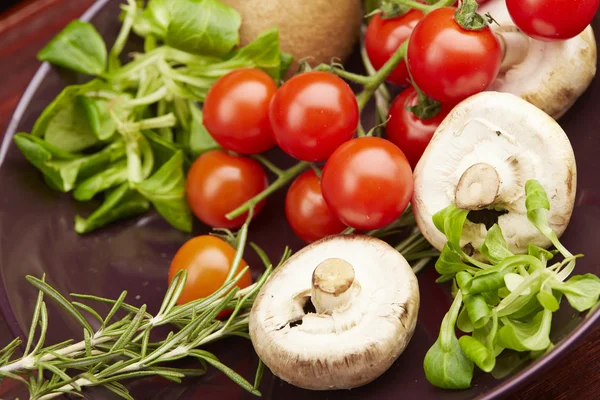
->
365, 0, 599, 168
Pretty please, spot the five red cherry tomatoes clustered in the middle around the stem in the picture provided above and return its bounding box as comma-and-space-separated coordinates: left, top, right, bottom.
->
187, 69, 412, 242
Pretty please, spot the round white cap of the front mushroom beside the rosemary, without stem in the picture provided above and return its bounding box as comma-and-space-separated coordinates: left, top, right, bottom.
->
249, 235, 419, 390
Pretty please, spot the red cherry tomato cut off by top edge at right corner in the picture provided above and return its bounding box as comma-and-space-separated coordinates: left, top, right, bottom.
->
506, 0, 599, 40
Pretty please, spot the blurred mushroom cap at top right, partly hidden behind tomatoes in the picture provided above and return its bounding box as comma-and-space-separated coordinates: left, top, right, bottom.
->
479, 0, 597, 119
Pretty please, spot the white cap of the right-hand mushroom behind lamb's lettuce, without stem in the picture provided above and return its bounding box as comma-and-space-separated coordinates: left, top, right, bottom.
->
412, 92, 577, 255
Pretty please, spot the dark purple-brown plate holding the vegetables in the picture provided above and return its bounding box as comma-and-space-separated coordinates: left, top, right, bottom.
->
0, 0, 600, 399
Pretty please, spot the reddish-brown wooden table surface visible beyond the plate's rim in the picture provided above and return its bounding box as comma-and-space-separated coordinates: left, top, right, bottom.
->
0, 0, 600, 400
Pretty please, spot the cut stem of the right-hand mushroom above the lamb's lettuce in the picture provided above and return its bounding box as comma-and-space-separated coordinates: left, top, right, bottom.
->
454, 163, 500, 210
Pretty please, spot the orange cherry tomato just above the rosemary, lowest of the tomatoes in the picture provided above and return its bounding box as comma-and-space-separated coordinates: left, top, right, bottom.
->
169, 235, 252, 304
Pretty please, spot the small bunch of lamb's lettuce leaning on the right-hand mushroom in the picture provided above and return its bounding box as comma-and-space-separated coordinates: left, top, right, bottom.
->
424, 180, 600, 389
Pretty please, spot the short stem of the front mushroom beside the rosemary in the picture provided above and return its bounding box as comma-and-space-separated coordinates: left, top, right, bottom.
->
311, 258, 356, 315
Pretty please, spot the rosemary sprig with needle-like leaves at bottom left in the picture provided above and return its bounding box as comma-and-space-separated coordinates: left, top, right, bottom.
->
0, 217, 290, 400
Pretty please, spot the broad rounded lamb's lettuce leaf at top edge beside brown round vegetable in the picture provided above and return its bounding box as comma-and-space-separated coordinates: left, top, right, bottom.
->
162, 0, 242, 56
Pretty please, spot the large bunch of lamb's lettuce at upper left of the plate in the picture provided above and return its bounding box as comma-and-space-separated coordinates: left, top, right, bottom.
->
14, 0, 291, 233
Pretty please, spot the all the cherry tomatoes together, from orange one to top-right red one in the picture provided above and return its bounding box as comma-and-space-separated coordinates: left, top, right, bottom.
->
170, 0, 600, 303
